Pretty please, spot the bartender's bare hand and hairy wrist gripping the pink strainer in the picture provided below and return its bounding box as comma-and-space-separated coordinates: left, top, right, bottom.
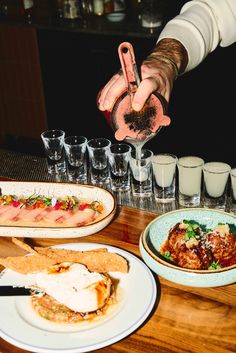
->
98, 38, 188, 111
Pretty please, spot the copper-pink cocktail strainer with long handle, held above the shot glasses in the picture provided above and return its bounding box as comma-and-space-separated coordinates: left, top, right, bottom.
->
111, 42, 171, 141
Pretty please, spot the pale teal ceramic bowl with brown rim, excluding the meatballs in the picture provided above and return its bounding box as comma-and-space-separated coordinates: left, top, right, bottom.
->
139, 209, 236, 287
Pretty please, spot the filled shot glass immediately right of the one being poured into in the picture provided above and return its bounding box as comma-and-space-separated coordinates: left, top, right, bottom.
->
152, 153, 178, 202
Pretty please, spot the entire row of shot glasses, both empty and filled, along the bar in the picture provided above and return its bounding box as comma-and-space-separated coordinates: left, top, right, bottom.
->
41, 130, 236, 213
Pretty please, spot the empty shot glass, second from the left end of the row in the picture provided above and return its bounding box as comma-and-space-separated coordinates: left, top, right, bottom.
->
64, 136, 87, 184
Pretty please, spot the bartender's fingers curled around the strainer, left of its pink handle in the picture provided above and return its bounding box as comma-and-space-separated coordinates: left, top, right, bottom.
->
98, 73, 126, 111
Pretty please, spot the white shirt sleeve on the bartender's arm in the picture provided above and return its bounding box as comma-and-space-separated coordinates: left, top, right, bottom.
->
158, 0, 236, 71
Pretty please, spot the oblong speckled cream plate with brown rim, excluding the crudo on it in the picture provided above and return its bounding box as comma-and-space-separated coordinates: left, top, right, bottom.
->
0, 181, 116, 238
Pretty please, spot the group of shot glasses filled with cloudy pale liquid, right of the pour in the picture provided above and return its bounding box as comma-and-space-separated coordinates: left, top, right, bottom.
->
152, 153, 236, 213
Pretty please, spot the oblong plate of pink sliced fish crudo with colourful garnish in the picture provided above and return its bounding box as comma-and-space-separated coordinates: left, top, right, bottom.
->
0, 181, 116, 238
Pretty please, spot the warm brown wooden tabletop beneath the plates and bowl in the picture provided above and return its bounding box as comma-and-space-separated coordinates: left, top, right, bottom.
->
0, 206, 236, 353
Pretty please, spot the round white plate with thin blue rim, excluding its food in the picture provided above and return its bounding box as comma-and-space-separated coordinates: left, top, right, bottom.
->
0, 243, 157, 353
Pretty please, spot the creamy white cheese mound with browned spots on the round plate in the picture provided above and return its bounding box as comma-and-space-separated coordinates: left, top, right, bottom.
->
30, 262, 111, 313
